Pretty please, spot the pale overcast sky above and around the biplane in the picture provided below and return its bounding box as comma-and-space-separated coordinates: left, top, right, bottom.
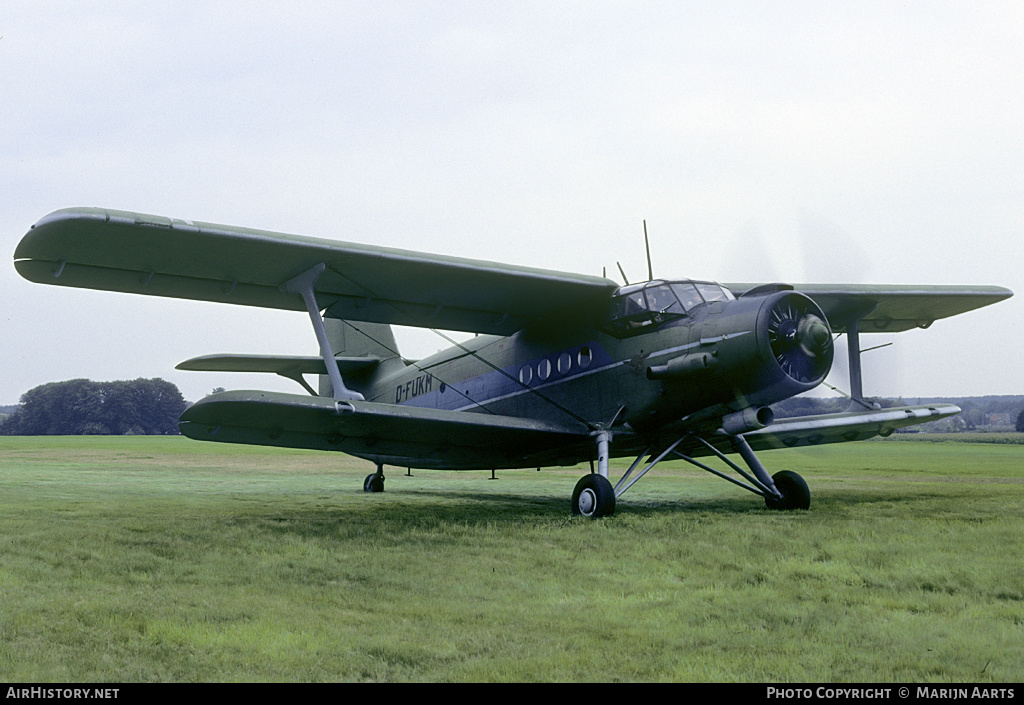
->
0, 0, 1024, 404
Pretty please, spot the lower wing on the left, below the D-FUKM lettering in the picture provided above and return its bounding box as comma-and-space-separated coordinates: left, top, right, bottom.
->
178, 391, 593, 469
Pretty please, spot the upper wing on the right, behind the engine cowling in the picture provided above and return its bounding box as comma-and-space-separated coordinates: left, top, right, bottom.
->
725, 284, 1014, 333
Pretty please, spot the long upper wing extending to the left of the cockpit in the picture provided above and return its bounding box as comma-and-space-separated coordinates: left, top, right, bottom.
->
14, 208, 615, 335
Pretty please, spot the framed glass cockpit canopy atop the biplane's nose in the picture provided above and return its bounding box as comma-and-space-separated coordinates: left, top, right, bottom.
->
607, 281, 734, 334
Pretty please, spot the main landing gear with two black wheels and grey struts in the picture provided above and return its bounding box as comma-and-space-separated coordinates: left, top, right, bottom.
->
572, 431, 811, 519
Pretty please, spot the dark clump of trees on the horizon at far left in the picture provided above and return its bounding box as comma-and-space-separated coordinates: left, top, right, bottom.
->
0, 378, 188, 436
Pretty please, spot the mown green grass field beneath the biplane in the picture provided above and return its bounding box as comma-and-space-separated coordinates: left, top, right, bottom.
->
0, 437, 1024, 683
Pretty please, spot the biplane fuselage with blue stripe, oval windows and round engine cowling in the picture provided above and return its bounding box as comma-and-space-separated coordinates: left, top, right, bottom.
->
344, 285, 831, 461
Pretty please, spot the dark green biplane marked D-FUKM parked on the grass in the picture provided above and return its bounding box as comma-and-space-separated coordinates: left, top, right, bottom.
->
14, 208, 1013, 516
